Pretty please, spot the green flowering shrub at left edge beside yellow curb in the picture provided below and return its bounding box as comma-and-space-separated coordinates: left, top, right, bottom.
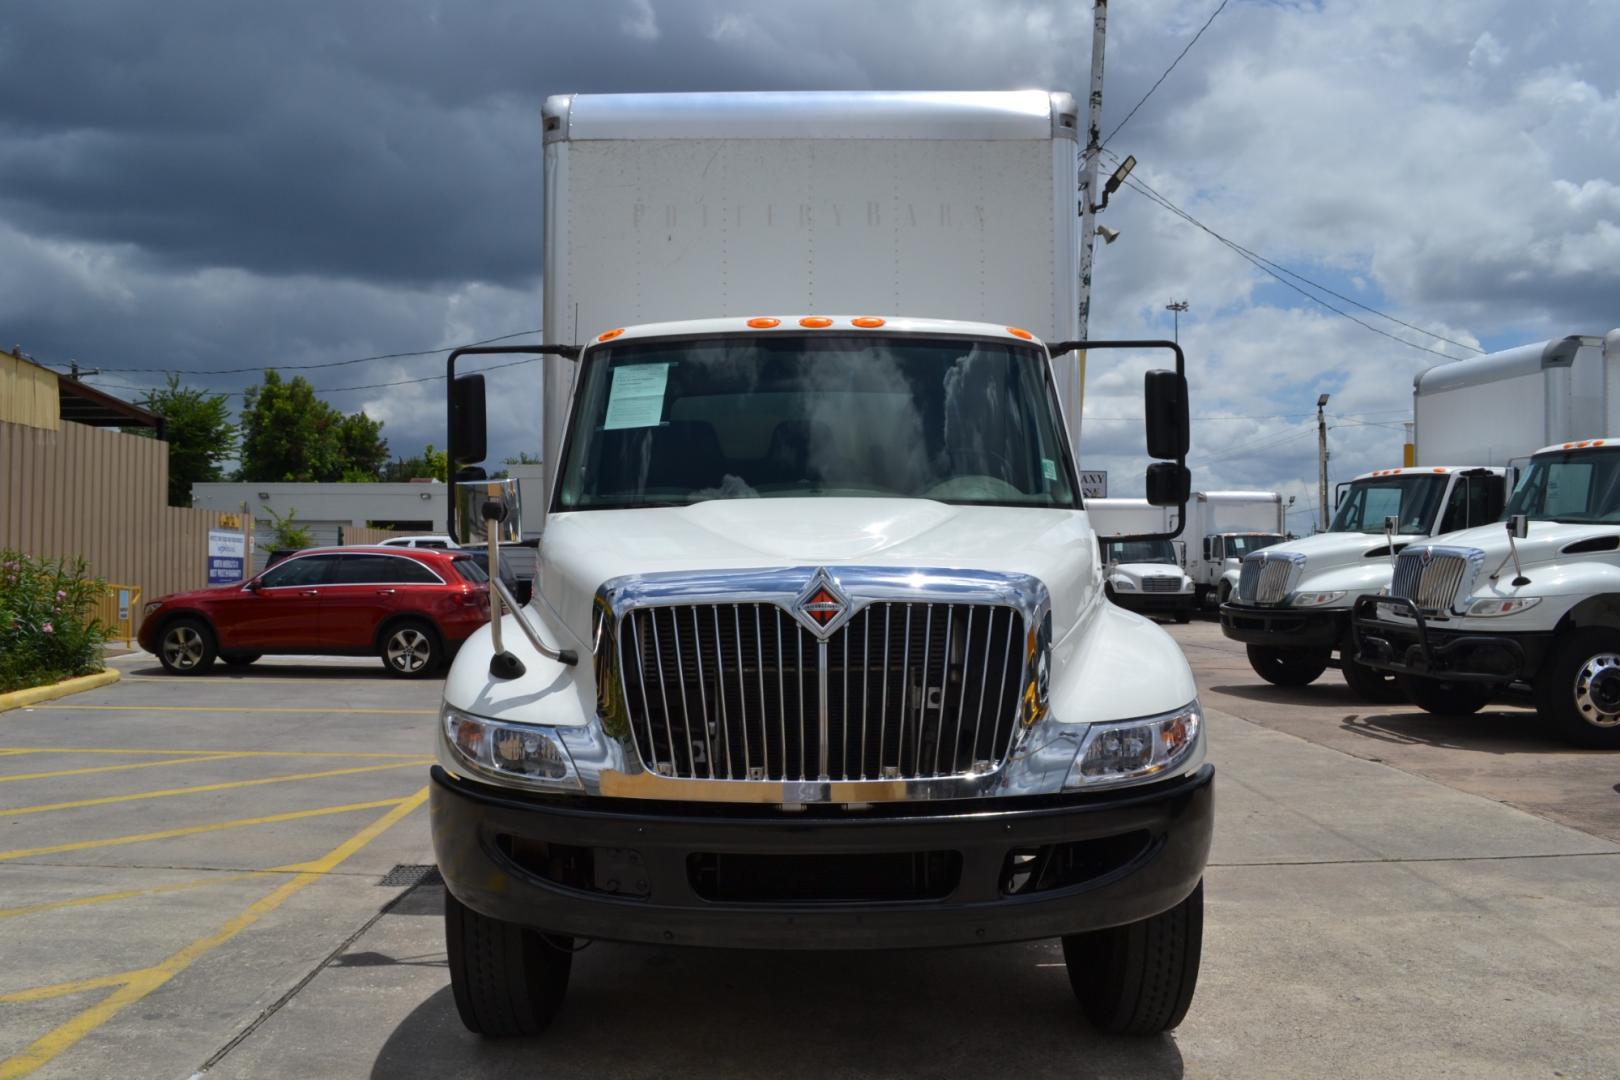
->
0, 551, 109, 693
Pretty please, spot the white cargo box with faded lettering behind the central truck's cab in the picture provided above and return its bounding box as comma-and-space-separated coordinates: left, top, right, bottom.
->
530, 91, 1081, 514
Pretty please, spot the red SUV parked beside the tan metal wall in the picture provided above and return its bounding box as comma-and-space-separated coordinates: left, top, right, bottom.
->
139, 547, 489, 677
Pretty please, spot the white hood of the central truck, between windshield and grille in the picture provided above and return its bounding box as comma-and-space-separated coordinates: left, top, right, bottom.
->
535, 499, 1095, 648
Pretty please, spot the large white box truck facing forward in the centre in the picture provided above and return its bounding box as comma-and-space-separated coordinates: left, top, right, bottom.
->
431, 92, 1213, 1035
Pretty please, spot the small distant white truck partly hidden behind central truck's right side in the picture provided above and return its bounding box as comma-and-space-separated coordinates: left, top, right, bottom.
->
1085, 499, 1197, 622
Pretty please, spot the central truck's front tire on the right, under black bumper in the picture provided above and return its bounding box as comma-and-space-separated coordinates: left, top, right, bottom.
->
1063, 881, 1204, 1035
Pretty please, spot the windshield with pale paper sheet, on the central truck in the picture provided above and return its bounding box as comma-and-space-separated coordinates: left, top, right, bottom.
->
557, 334, 1079, 510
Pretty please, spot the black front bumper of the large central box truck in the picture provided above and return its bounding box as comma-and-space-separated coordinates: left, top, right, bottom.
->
433, 766, 1215, 949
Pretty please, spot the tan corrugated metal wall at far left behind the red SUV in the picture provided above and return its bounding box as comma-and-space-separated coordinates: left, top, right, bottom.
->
0, 421, 224, 599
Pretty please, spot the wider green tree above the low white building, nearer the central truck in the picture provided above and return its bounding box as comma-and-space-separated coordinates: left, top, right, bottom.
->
238, 369, 389, 483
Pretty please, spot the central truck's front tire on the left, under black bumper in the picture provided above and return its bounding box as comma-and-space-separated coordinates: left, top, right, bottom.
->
444, 891, 573, 1038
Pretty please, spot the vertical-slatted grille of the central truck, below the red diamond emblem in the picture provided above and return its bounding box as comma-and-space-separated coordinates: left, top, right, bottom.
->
615, 602, 1027, 780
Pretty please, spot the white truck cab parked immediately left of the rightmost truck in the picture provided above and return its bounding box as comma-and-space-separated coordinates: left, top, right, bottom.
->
1220, 465, 1507, 703
